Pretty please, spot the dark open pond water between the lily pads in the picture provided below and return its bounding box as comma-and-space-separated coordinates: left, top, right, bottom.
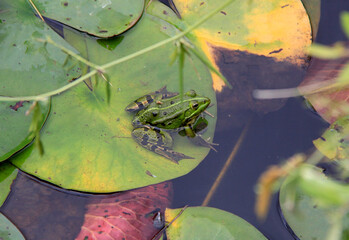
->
0, 0, 349, 240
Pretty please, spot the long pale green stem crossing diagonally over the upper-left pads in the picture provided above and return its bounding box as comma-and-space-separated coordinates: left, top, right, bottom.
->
0, 0, 235, 102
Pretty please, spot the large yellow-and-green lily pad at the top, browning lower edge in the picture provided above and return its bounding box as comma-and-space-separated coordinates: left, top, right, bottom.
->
149, 0, 314, 92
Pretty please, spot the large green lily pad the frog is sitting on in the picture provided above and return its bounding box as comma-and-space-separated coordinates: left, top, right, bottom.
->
11, 14, 216, 192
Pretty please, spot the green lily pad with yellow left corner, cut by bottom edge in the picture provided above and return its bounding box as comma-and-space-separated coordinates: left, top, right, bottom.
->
165, 207, 266, 240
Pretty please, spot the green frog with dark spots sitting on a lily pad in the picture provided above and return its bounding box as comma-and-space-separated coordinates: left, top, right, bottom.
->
125, 87, 215, 164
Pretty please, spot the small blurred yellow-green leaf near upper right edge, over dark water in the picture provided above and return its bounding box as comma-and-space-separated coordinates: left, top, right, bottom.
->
308, 43, 346, 59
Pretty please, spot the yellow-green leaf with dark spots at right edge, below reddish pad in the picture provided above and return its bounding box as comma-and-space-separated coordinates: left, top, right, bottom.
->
314, 116, 349, 159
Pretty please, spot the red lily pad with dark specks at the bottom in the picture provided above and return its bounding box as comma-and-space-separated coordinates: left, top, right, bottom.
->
76, 182, 172, 240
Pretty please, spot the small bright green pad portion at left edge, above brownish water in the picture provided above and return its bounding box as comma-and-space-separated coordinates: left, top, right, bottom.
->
0, 162, 18, 207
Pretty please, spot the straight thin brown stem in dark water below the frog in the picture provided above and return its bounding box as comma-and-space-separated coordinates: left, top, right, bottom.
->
201, 119, 251, 207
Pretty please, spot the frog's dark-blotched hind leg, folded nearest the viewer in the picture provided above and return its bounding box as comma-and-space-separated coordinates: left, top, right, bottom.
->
132, 126, 193, 164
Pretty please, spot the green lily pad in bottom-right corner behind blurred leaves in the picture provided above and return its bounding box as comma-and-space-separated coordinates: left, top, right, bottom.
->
279, 169, 349, 240
